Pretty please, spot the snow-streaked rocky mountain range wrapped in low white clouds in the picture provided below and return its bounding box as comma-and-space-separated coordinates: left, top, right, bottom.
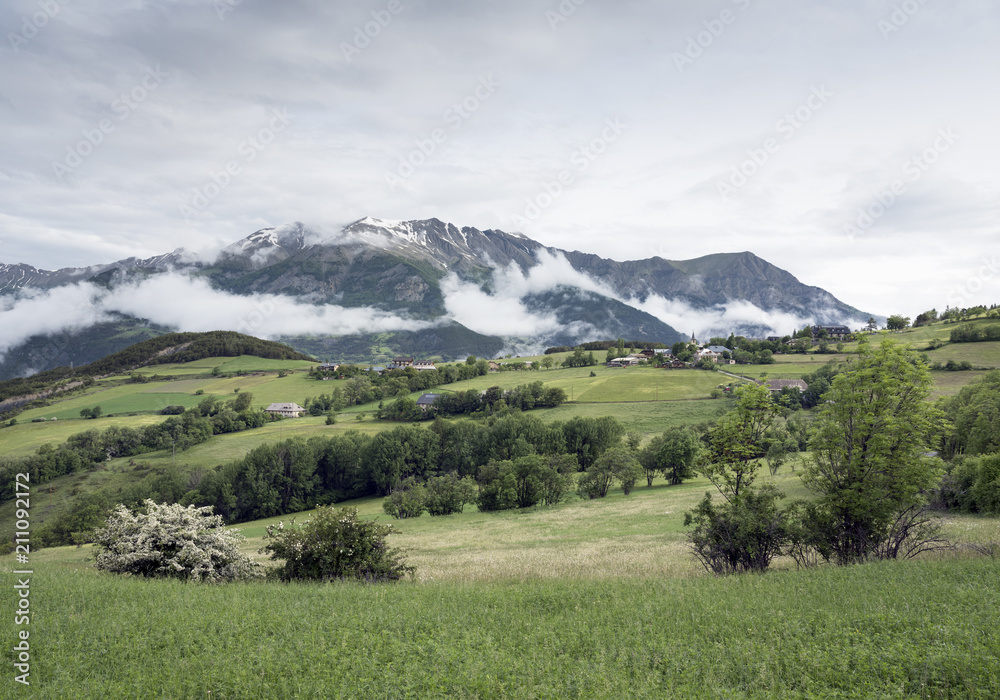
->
0, 217, 871, 378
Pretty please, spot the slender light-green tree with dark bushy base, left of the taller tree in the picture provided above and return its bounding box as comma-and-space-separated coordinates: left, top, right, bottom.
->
684, 384, 788, 574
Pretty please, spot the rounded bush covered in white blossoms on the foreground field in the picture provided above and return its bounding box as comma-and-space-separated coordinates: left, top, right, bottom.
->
94, 499, 262, 583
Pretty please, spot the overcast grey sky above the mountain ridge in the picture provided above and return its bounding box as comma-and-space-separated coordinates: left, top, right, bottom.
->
0, 0, 1000, 315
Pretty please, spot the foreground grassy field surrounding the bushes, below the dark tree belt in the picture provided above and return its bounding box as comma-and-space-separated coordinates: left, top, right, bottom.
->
0, 473, 1000, 700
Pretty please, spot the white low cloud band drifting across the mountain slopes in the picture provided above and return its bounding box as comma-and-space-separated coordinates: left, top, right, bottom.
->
0, 250, 868, 357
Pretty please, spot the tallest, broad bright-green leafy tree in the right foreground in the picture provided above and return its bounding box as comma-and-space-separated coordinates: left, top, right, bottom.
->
802, 339, 943, 564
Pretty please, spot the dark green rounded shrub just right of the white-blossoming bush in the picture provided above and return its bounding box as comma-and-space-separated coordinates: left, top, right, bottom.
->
260, 506, 415, 583
